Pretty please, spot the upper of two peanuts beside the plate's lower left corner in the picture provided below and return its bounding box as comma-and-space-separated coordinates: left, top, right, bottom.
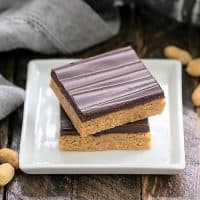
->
0, 148, 19, 169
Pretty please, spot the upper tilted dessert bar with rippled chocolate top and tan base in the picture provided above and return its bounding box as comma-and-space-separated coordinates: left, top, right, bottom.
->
51, 47, 165, 136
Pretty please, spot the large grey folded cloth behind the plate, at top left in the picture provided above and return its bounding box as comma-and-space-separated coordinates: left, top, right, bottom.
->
0, 0, 120, 54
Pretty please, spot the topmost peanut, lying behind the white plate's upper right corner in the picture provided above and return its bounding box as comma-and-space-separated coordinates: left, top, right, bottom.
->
164, 45, 192, 65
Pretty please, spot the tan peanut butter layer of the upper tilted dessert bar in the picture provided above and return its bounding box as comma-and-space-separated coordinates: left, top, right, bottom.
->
50, 80, 165, 137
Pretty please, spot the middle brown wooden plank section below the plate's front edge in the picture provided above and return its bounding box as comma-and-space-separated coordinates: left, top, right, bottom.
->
72, 175, 141, 200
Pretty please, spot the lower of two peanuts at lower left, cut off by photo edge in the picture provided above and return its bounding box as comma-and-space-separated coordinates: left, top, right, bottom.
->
0, 163, 15, 186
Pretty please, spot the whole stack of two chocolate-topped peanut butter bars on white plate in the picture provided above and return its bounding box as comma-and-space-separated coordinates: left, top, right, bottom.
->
50, 47, 165, 151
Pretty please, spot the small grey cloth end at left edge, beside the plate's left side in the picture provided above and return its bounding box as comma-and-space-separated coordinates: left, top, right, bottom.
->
0, 75, 24, 120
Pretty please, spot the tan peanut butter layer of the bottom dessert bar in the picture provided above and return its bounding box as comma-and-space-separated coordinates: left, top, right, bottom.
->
59, 133, 151, 151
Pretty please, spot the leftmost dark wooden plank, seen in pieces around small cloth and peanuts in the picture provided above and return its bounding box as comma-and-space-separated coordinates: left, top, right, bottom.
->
0, 53, 15, 200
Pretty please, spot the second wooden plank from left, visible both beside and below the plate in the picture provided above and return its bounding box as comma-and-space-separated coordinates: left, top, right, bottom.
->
5, 51, 72, 200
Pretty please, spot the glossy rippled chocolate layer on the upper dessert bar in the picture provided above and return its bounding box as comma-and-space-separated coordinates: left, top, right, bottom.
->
51, 47, 164, 121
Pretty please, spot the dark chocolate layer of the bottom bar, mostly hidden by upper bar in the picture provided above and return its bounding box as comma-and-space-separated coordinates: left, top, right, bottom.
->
60, 108, 149, 136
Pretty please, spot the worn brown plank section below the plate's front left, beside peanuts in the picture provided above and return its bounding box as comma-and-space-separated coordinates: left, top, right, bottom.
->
5, 171, 72, 200
